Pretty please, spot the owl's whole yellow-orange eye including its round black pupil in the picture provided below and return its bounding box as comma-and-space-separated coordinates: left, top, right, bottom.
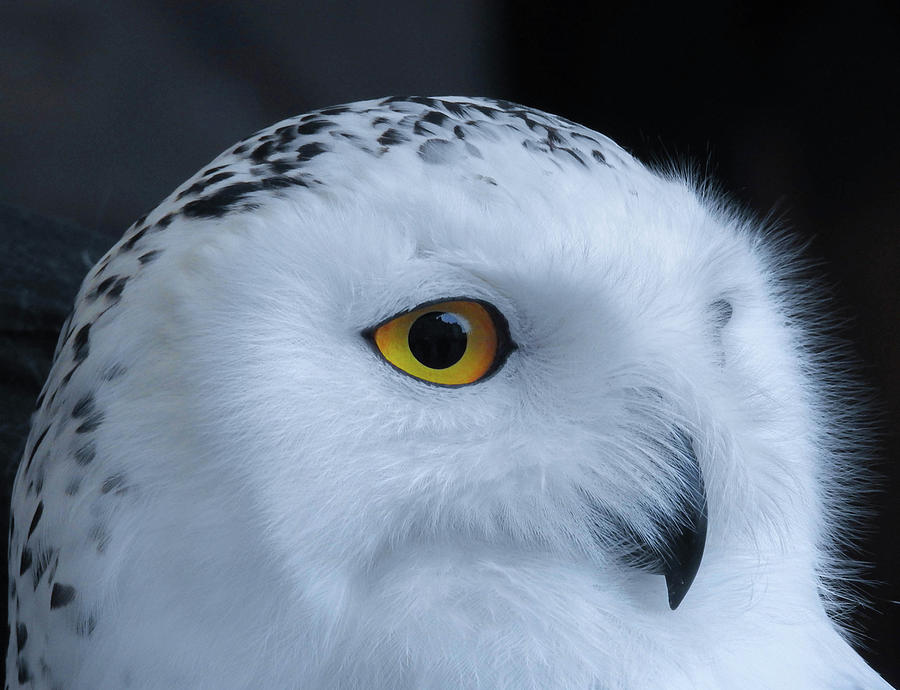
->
363, 299, 515, 386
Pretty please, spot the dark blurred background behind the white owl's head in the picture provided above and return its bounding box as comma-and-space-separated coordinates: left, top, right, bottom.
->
0, 0, 900, 685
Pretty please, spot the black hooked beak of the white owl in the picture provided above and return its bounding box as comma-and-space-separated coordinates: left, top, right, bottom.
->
657, 428, 707, 611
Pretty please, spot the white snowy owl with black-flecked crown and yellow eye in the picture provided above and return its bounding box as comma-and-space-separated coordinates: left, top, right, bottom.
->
6, 97, 889, 690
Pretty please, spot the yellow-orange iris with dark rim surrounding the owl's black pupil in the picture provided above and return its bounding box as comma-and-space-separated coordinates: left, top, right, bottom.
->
363, 297, 515, 387
